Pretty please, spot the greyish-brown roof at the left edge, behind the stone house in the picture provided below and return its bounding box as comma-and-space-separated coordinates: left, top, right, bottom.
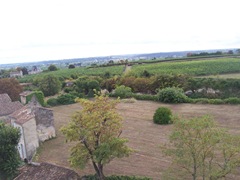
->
0, 94, 23, 116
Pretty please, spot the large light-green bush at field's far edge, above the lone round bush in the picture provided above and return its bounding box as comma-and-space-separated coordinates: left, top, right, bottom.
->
157, 87, 187, 103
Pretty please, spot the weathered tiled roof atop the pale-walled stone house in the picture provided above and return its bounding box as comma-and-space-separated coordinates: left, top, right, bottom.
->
10, 106, 34, 125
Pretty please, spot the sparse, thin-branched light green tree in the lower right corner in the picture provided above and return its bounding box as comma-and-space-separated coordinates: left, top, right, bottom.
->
163, 116, 240, 180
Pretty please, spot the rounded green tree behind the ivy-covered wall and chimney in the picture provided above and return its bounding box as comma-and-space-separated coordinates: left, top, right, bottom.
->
38, 75, 61, 96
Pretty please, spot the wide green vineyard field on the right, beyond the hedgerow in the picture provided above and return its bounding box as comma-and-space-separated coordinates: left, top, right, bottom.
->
129, 58, 240, 76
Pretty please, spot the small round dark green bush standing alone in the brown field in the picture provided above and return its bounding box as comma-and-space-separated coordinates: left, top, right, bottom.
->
153, 107, 172, 124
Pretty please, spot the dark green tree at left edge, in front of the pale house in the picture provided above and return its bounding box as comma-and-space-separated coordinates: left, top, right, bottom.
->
0, 122, 20, 179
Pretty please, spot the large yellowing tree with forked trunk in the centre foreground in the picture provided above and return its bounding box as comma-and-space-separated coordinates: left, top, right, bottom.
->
61, 96, 132, 180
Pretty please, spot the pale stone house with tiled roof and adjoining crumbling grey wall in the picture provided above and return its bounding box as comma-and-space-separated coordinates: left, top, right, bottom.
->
9, 96, 56, 160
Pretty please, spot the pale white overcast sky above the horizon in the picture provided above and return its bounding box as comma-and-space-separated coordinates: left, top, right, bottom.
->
0, 0, 240, 64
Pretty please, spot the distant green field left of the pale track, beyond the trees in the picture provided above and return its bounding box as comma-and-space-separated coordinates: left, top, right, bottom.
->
19, 66, 124, 82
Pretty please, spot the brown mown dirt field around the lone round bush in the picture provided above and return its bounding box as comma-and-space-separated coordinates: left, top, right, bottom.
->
36, 101, 240, 179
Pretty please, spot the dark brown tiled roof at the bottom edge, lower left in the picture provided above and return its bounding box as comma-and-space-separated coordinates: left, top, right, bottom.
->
14, 163, 80, 180
